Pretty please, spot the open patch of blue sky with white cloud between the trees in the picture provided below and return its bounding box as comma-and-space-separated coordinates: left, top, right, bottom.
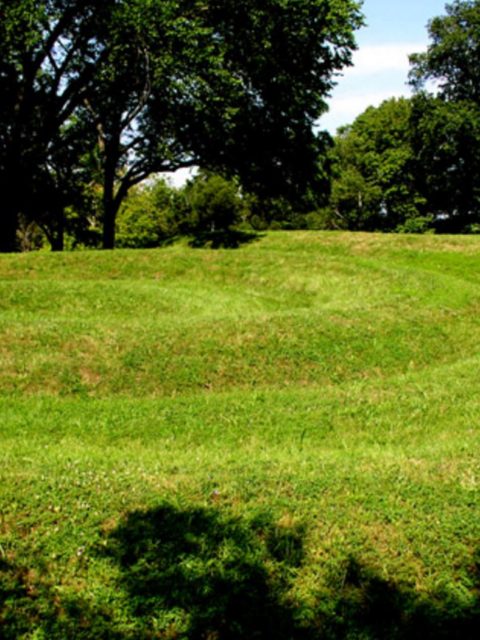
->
319, 0, 446, 133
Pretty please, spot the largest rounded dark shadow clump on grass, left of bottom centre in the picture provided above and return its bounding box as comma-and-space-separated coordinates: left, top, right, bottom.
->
103, 505, 306, 640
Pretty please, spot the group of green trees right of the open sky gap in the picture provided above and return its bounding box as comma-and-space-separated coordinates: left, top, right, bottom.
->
330, 0, 480, 232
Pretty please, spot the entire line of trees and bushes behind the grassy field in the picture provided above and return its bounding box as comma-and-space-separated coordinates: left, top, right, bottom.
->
0, 0, 480, 251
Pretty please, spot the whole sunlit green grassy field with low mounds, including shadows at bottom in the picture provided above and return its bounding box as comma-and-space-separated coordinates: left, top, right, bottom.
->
0, 232, 480, 640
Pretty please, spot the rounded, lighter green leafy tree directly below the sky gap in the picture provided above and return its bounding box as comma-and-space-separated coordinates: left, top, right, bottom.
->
330, 98, 422, 231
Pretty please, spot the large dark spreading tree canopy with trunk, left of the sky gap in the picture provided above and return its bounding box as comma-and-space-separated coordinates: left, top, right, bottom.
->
0, 0, 361, 251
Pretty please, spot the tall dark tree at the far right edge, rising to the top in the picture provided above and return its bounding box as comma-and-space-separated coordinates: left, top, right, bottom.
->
410, 0, 480, 231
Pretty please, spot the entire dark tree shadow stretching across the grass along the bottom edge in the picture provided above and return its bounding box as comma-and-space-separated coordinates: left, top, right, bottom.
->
0, 504, 480, 640
